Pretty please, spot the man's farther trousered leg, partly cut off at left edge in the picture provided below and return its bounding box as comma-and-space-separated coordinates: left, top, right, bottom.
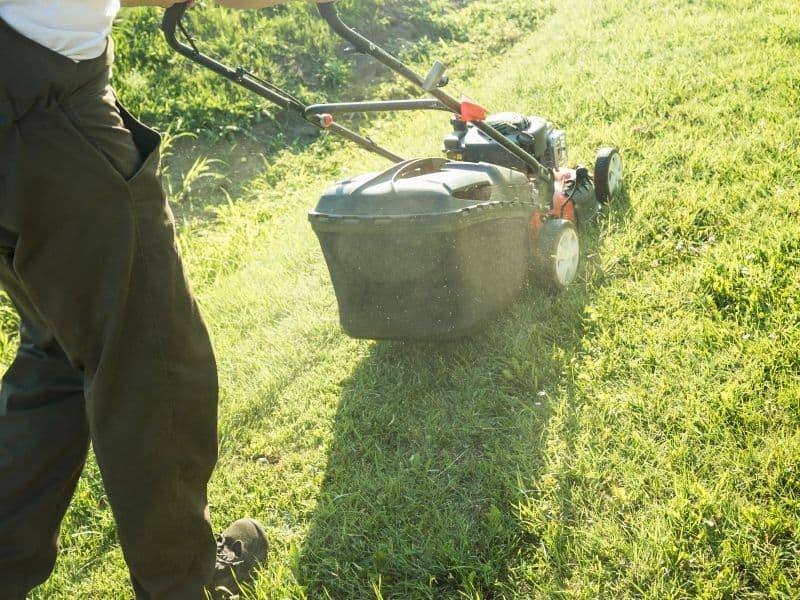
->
0, 264, 89, 600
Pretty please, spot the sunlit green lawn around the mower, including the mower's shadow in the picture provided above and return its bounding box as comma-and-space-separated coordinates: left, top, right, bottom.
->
28, 0, 800, 599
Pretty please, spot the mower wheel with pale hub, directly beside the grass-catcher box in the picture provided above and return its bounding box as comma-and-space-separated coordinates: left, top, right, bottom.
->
535, 219, 581, 291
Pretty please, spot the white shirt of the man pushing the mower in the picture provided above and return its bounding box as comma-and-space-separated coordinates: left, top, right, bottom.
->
0, 0, 119, 60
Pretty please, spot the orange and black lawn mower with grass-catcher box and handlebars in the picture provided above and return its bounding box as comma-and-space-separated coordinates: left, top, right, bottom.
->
162, 3, 622, 340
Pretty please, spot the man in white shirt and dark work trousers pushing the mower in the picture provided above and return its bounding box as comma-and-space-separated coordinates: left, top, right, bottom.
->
0, 0, 331, 600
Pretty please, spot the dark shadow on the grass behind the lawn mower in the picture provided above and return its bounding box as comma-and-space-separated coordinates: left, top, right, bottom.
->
296, 197, 629, 599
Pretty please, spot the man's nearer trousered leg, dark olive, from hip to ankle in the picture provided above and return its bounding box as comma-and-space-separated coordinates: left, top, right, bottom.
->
0, 32, 217, 600
